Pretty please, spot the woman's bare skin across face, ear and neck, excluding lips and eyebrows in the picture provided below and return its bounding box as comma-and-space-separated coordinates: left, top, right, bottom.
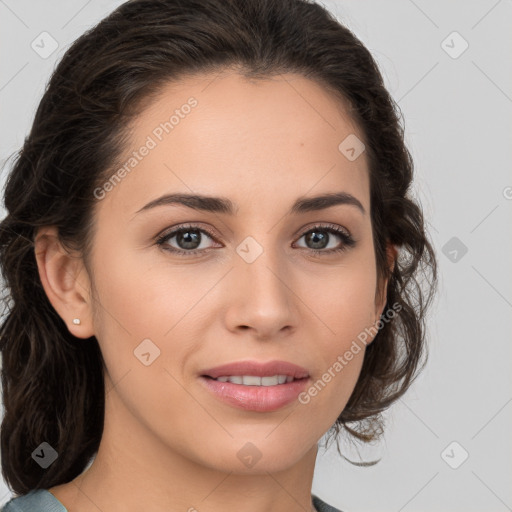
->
36, 72, 392, 512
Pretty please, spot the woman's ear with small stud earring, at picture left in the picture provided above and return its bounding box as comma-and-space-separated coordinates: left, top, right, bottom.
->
34, 226, 94, 338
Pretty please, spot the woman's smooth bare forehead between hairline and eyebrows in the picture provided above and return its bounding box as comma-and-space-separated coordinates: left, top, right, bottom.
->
97, 72, 369, 215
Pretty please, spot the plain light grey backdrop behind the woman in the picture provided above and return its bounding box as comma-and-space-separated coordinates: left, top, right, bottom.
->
0, 0, 512, 512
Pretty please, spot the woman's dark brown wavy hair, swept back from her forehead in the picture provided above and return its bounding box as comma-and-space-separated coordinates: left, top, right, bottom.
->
0, 0, 437, 494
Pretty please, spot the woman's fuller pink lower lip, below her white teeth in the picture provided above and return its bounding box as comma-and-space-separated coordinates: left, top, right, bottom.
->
200, 376, 310, 412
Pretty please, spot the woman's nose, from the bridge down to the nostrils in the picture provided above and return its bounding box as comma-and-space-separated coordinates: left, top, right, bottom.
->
225, 240, 300, 339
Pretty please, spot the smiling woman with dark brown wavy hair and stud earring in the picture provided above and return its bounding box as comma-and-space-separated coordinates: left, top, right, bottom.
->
0, 0, 436, 512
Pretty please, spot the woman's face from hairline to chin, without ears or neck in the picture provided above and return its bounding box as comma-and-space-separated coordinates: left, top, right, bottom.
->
78, 73, 383, 472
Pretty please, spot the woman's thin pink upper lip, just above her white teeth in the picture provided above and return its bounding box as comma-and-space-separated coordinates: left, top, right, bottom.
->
201, 361, 309, 379
